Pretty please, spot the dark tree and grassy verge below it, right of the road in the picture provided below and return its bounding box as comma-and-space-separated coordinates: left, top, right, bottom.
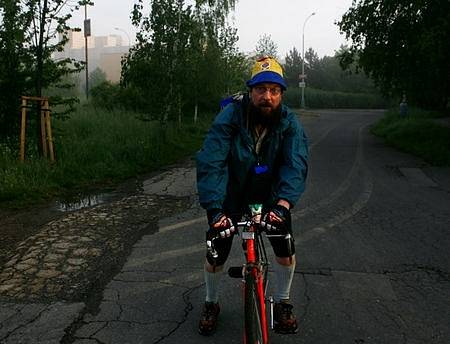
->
337, 0, 450, 166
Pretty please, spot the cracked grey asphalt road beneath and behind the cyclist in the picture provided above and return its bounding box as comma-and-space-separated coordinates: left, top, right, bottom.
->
0, 111, 450, 344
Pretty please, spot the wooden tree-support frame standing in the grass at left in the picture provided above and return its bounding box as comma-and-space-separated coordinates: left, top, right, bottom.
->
20, 96, 55, 162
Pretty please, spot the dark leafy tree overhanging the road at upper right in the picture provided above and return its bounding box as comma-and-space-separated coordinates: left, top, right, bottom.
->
338, 0, 450, 109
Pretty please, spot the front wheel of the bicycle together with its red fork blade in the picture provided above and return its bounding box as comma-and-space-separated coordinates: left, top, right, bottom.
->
244, 272, 268, 344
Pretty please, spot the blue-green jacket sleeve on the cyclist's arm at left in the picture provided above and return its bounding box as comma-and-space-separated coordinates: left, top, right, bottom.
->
196, 104, 235, 210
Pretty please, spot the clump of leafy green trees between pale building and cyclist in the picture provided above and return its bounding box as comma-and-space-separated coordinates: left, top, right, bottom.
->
121, 0, 245, 122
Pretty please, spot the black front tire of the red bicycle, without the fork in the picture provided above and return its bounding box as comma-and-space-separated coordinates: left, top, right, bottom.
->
244, 272, 265, 344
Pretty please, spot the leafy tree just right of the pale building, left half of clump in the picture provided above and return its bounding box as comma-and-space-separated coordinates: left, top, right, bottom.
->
122, 0, 198, 122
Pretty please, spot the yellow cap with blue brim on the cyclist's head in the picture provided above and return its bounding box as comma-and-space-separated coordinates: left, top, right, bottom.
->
247, 56, 287, 90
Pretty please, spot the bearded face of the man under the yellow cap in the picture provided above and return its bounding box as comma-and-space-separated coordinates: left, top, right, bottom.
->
250, 83, 282, 116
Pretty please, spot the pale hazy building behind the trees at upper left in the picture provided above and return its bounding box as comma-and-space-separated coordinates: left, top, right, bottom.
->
53, 30, 130, 82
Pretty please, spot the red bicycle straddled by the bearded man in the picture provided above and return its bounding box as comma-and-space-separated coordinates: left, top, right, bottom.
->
207, 204, 290, 344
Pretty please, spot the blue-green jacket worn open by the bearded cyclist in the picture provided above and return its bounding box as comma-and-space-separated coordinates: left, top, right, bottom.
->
197, 99, 308, 213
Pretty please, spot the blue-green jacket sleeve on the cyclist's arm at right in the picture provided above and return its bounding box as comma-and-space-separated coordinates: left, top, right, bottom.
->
277, 115, 308, 207
